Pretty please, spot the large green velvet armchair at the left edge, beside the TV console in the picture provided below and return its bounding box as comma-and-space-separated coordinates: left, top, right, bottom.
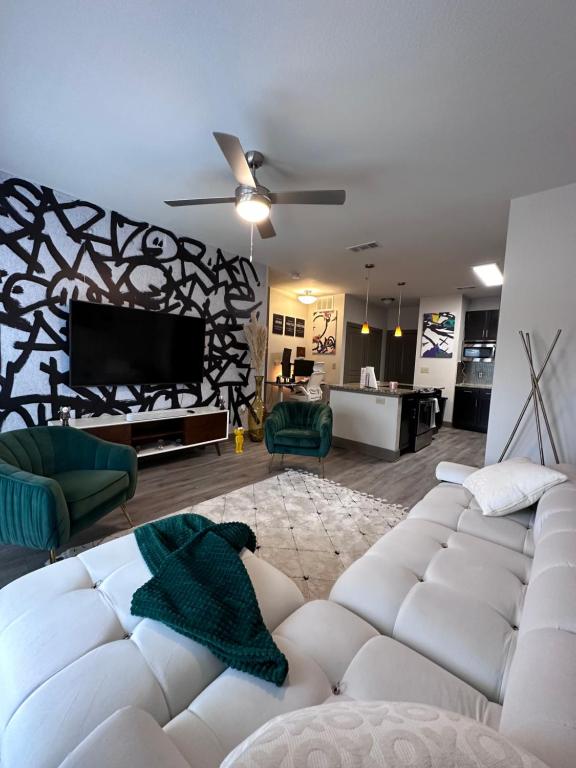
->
0, 426, 138, 562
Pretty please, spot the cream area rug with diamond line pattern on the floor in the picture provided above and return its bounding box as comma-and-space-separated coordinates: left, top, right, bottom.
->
62, 469, 408, 600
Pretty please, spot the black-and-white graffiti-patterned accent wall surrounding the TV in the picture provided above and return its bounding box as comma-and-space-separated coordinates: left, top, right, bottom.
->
0, 176, 262, 429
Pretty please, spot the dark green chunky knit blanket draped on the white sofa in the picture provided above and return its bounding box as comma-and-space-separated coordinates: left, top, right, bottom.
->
131, 514, 288, 686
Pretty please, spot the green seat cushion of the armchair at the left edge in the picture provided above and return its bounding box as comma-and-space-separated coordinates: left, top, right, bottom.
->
52, 469, 130, 522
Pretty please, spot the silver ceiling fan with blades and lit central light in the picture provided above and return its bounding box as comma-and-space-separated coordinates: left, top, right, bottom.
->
164, 133, 346, 238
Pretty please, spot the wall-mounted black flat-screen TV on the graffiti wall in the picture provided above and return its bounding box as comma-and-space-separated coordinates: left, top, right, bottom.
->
68, 301, 206, 387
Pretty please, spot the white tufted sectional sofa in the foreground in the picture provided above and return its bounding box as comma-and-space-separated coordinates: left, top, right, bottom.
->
0, 464, 576, 768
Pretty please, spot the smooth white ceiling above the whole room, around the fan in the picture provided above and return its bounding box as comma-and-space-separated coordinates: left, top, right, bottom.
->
0, 0, 576, 297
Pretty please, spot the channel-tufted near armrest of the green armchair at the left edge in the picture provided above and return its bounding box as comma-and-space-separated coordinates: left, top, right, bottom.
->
0, 462, 70, 549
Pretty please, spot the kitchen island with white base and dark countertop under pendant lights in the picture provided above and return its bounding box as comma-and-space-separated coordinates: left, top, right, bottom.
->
330, 384, 434, 461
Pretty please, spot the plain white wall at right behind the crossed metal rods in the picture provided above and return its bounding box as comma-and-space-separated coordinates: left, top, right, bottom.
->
486, 184, 576, 463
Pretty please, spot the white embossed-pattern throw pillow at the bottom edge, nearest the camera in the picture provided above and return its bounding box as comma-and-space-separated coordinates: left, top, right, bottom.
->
221, 701, 546, 768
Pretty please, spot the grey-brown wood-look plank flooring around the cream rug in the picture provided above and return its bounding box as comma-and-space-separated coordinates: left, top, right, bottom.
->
0, 427, 486, 586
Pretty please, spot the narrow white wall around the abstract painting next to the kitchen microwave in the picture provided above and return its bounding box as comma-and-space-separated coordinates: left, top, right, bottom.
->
414, 294, 466, 421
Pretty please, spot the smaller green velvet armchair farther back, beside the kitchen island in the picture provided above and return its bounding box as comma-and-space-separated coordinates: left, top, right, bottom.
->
264, 400, 332, 474
